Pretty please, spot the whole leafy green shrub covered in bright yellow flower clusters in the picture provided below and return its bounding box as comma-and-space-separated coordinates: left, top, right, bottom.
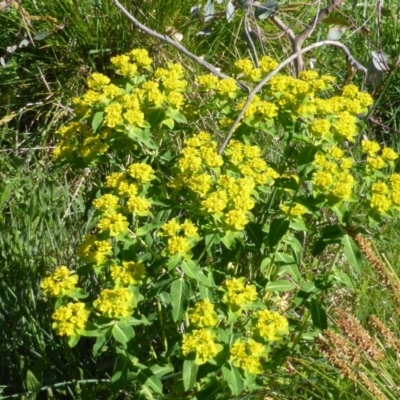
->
42, 49, 400, 398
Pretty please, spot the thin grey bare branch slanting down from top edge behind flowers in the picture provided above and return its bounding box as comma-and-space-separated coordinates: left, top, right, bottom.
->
114, 0, 250, 92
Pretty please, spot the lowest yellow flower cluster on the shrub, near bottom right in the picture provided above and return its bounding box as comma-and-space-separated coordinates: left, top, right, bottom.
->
230, 338, 266, 375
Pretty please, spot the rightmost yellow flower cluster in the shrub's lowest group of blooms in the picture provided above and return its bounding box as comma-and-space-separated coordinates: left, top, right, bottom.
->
256, 310, 289, 342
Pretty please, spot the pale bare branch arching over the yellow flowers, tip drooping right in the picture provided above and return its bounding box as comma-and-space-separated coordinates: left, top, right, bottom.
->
218, 40, 367, 154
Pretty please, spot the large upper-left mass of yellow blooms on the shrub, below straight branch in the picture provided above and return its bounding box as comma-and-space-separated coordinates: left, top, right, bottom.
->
53, 49, 191, 164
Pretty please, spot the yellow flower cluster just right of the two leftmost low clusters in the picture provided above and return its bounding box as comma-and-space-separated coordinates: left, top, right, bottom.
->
93, 288, 136, 318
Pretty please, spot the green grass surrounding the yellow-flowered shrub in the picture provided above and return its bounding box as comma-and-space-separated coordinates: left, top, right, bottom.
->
0, 0, 400, 399
